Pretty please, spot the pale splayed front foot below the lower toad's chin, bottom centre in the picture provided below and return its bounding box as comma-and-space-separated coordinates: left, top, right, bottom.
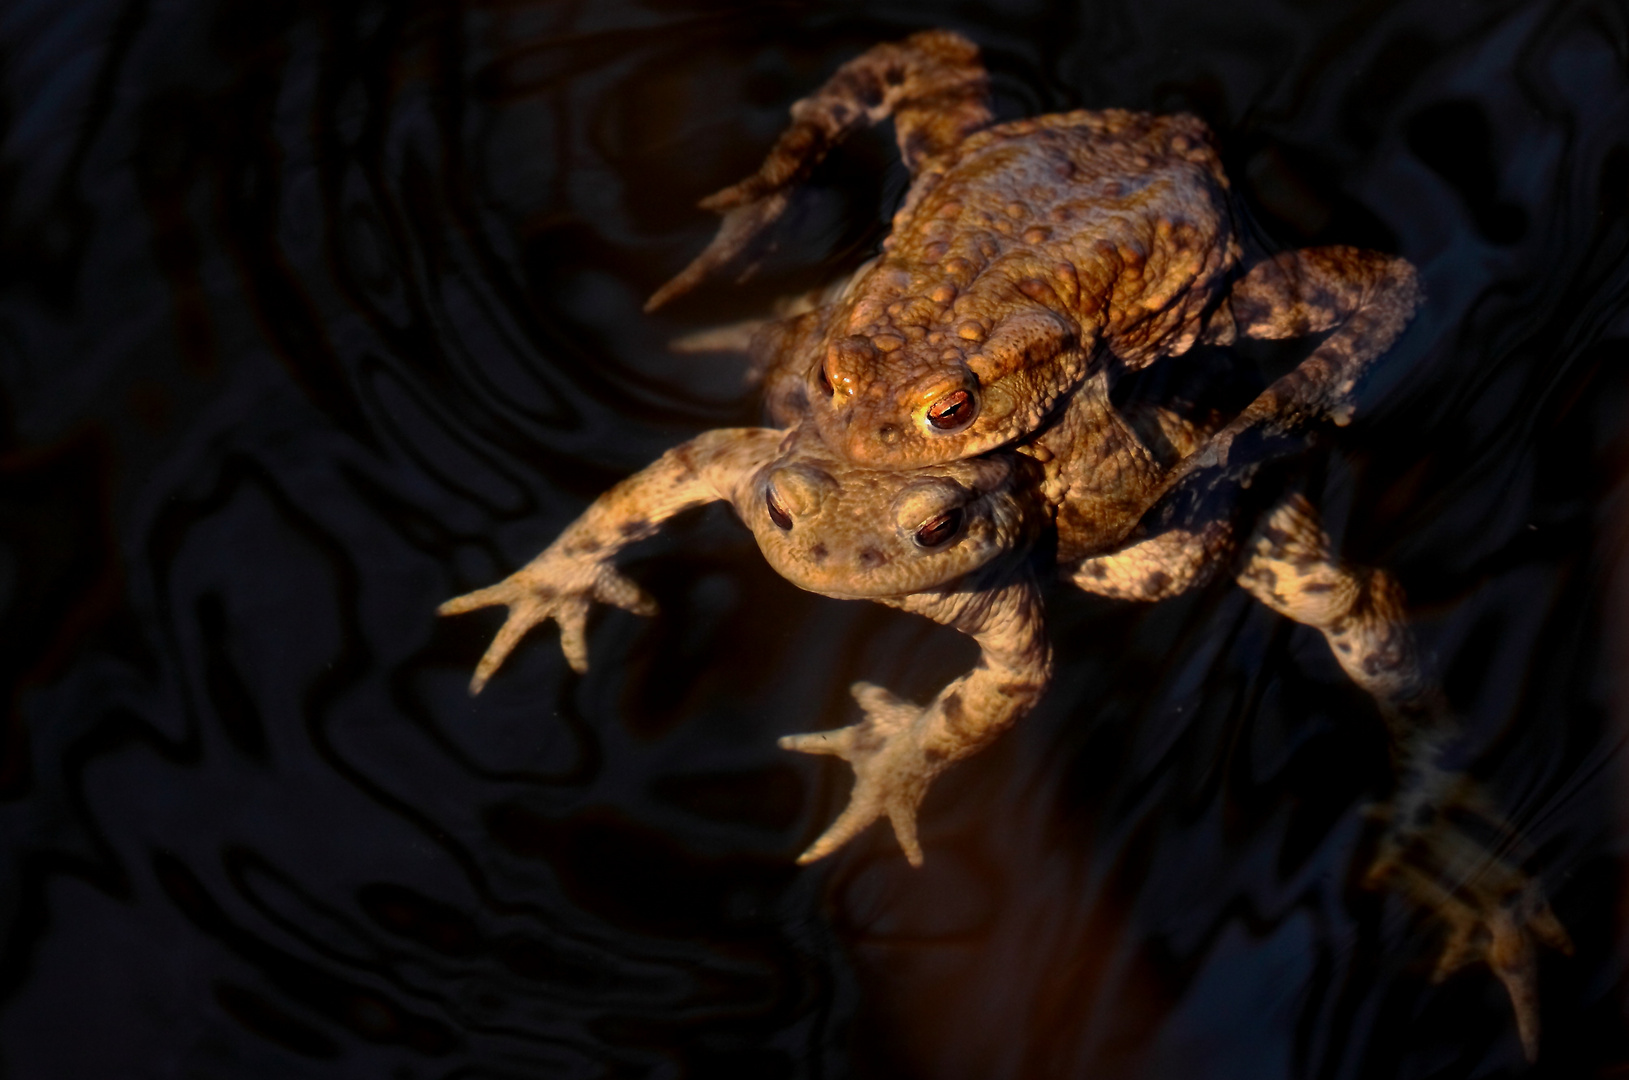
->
780, 683, 950, 867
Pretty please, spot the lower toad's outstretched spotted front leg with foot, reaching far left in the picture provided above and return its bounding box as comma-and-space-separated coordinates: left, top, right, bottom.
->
438, 428, 784, 694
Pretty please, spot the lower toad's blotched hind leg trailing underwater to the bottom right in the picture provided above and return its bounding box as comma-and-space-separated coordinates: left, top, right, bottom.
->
1238, 495, 1572, 1060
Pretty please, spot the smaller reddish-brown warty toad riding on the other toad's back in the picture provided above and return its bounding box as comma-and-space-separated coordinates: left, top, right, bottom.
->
647, 31, 1419, 478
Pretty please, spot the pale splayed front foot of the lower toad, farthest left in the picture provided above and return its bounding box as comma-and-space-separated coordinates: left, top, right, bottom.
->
437, 552, 656, 694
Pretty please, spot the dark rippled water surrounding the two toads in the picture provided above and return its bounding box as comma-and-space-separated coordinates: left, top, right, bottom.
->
0, 0, 1629, 1080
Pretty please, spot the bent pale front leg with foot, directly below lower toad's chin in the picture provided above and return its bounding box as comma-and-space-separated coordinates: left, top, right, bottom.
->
780, 570, 1052, 867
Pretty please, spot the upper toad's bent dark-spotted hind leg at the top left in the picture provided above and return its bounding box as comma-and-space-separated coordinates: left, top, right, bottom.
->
645, 29, 994, 311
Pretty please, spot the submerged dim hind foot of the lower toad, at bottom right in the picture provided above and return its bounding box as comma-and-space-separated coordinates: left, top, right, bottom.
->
1363, 787, 1572, 1060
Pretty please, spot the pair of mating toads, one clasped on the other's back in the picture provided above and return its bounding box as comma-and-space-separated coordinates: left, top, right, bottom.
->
441, 31, 1567, 1057
